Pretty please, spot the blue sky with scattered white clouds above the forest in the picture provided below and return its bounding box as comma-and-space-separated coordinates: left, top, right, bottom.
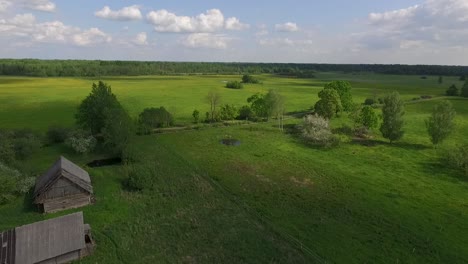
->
0, 0, 468, 65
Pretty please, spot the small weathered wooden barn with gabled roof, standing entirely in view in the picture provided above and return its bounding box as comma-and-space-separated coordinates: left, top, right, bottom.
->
34, 156, 93, 213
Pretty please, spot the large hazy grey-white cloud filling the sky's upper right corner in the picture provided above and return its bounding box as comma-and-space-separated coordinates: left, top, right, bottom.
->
359, 0, 468, 50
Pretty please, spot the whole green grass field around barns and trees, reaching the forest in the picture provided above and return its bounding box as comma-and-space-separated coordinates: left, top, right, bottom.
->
0, 73, 468, 263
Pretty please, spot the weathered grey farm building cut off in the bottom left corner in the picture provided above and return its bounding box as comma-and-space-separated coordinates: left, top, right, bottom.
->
0, 212, 93, 264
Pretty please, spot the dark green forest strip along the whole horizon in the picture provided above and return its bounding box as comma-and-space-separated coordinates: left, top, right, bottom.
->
0, 59, 468, 78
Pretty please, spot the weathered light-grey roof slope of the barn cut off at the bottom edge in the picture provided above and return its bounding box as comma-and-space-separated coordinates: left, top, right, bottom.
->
15, 212, 86, 263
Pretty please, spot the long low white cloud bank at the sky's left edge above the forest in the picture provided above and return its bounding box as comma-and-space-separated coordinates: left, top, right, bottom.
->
0, 14, 111, 46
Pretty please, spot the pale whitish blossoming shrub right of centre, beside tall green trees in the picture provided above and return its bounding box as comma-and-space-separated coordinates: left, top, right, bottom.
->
302, 114, 338, 146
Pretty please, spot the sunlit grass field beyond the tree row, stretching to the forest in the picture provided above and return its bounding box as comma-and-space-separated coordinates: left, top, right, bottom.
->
0, 73, 461, 130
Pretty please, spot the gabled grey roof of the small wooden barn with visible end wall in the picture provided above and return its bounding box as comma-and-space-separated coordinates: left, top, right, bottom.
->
34, 156, 93, 196
